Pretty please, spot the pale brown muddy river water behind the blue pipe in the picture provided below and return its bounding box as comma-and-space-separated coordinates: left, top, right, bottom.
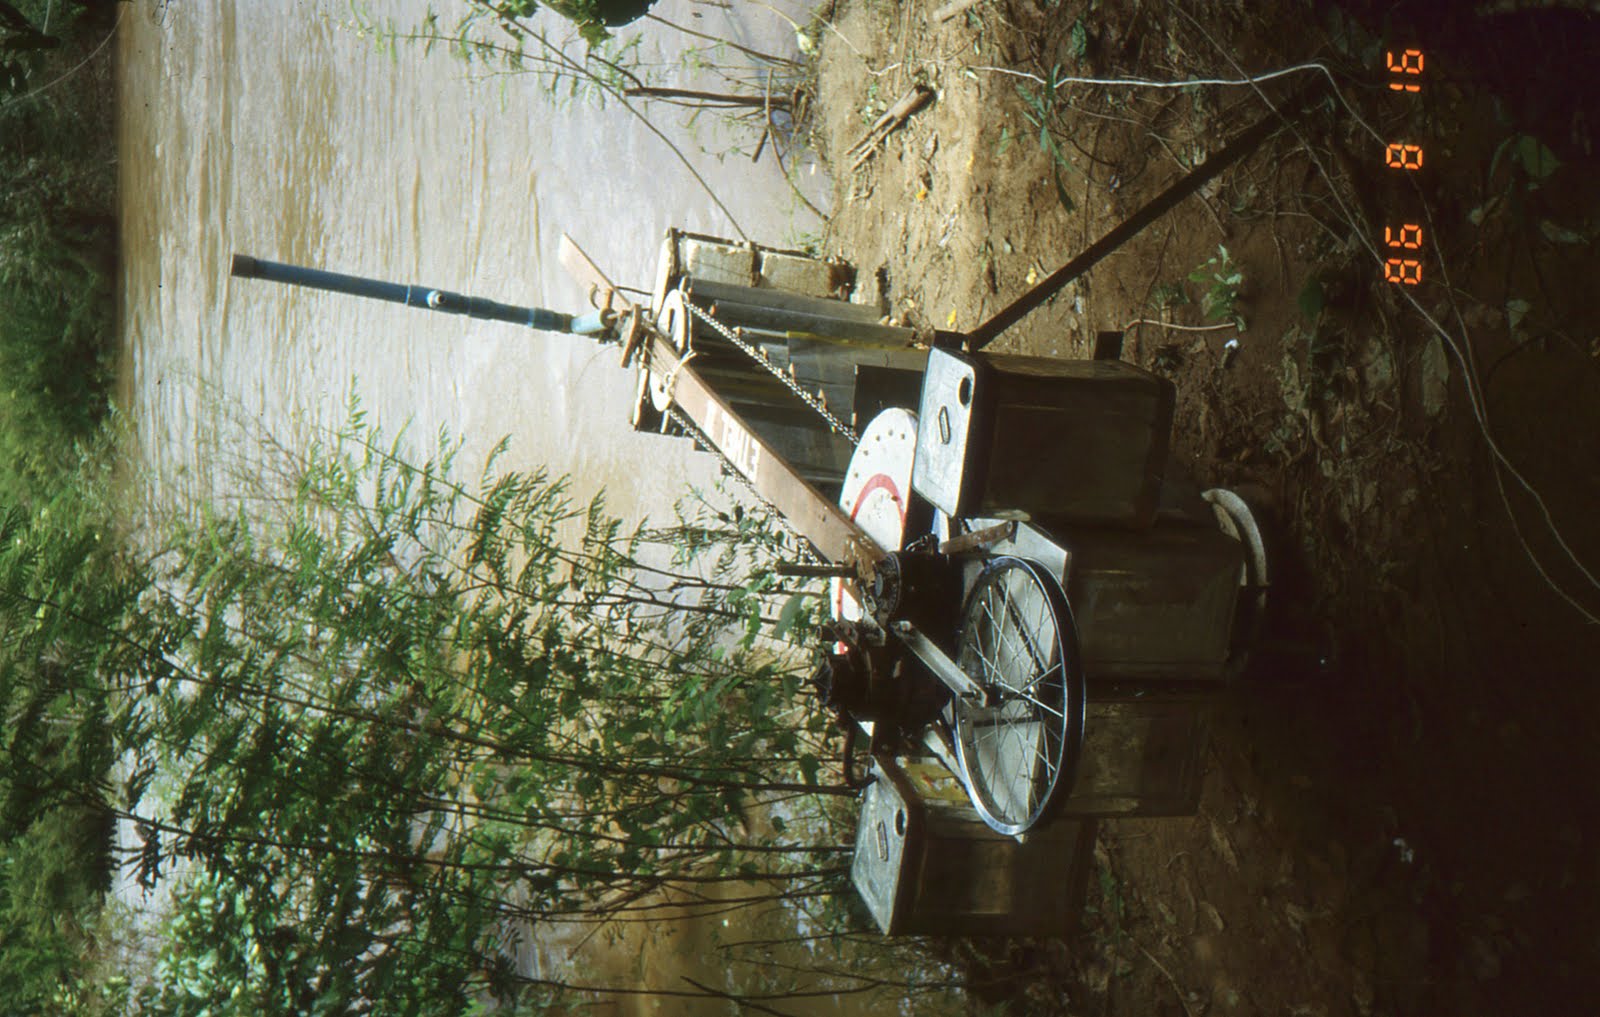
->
118, 0, 960, 1014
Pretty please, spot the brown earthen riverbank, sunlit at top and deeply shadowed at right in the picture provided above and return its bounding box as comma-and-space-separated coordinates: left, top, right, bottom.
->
814, 0, 1600, 1017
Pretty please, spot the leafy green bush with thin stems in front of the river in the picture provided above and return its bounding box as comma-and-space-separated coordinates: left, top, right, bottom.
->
0, 402, 850, 1014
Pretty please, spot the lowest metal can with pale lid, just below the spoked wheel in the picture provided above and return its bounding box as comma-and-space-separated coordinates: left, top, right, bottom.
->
850, 760, 1096, 935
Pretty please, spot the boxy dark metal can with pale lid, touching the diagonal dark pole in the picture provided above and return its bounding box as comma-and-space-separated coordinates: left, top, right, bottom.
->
912, 349, 1174, 528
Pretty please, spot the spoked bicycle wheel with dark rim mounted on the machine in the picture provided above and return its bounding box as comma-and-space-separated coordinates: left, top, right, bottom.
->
950, 556, 1083, 835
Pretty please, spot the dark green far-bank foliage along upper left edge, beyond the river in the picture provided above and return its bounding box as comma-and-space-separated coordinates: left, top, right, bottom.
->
0, 0, 117, 502
